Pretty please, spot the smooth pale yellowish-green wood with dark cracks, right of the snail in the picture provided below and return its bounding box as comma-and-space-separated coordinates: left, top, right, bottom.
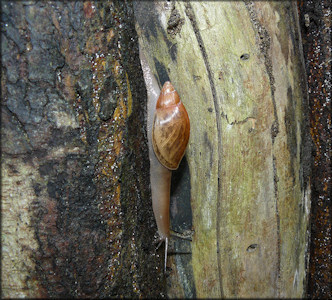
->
134, 1, 310, 298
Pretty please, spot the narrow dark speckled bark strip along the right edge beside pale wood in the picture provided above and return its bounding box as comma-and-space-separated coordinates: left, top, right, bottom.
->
298, 0, 332, 299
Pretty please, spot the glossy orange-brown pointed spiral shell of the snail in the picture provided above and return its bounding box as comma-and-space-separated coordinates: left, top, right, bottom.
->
152, 81, 190, 170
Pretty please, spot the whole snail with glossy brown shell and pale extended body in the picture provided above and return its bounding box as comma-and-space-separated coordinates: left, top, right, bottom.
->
140, 49, 190, 271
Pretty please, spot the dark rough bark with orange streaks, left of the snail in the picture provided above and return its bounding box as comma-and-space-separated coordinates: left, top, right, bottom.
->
1, 1, 164, 298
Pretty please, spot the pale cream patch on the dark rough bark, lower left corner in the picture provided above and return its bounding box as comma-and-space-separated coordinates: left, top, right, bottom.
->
1, 158, 44, 298
